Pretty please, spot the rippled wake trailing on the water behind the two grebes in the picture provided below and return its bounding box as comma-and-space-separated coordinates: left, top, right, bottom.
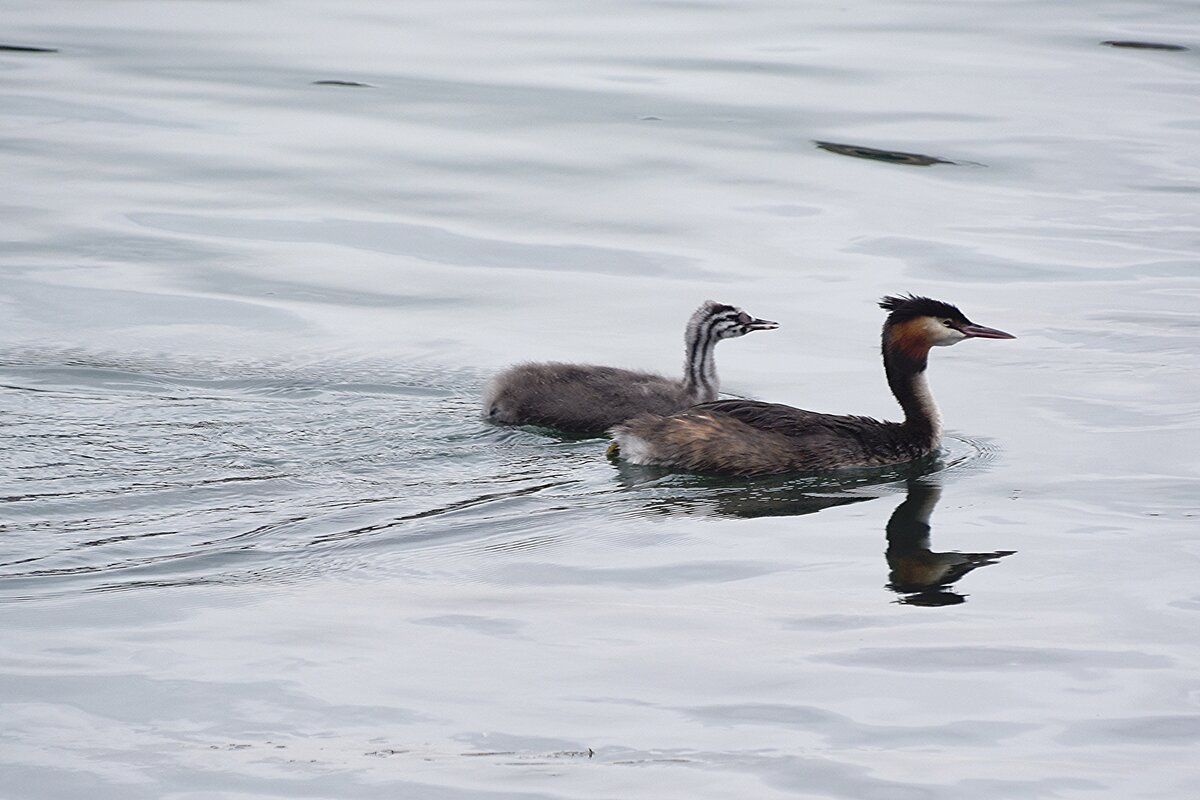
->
0, 357, 549, 599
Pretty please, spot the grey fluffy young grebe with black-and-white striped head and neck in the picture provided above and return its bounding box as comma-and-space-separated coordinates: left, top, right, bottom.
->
484, 300, 779, 434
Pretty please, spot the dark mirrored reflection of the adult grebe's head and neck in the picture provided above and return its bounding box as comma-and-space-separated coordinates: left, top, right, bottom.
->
887, 481, 1015, 606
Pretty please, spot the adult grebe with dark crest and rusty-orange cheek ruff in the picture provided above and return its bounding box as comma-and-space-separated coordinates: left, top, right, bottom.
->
610, 295, 1014, 475
